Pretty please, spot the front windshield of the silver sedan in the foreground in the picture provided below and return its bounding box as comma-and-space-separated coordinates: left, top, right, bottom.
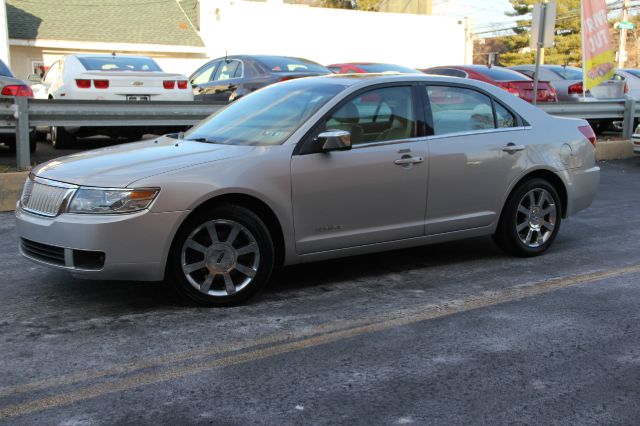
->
184, 79, 345, 145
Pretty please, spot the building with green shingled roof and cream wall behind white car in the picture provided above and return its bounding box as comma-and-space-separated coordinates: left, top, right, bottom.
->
6, 0, 207, 79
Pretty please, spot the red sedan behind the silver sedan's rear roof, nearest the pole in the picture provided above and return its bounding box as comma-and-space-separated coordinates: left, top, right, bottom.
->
420, 65, 558, 102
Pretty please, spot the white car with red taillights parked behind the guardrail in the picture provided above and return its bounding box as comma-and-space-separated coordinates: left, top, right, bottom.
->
31, 54, 193, 148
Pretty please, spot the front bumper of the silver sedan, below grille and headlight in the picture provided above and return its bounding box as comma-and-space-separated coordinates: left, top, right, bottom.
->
16, 203, 189, 281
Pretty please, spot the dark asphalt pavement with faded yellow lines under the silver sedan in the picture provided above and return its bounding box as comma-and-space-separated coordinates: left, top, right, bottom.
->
0, 158, 640, 424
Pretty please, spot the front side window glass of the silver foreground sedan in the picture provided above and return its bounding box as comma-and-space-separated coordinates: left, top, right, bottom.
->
325, 86, 416, 145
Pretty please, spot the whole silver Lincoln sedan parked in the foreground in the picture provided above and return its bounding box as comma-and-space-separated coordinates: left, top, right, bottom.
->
16, 74, 599, 305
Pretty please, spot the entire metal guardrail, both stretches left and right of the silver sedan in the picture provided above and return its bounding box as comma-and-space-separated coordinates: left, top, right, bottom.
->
0, 97, 640, 169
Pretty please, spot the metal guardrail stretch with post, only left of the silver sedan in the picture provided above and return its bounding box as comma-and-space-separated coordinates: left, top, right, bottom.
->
0, 97, 226, 169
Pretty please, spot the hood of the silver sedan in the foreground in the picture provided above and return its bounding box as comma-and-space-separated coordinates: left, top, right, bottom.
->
33, 136, 255, 188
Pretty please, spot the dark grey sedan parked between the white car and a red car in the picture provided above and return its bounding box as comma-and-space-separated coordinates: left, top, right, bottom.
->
189, 55, 331, 102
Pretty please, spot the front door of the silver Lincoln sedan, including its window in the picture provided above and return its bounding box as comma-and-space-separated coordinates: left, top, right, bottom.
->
291, 86, 428, 254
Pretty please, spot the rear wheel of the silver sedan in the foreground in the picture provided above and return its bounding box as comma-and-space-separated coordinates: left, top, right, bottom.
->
493, 178, 563, 257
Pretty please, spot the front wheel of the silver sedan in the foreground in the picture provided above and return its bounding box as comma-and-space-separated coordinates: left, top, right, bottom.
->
167, 205, 274, 306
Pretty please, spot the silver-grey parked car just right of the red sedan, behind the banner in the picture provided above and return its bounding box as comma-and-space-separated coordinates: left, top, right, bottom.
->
509, 64, 627, 102
